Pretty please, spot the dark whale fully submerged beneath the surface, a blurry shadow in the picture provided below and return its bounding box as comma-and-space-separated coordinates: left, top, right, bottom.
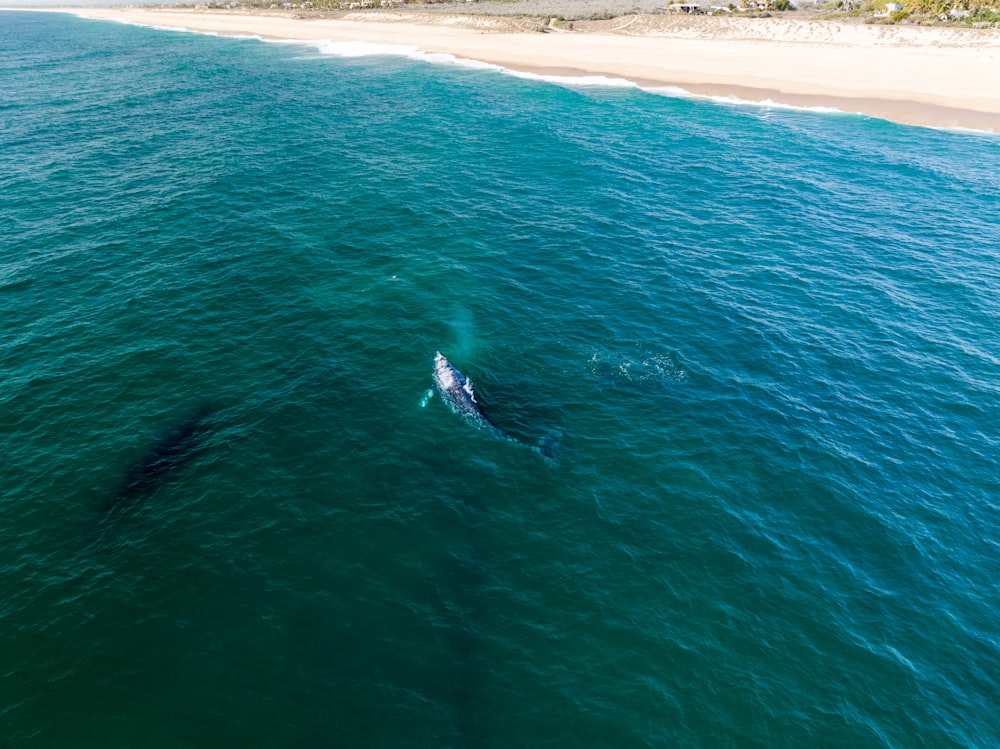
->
102, 407, 215, 524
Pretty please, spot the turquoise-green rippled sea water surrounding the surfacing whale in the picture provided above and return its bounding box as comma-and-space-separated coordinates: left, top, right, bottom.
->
0, 13, 1000, 749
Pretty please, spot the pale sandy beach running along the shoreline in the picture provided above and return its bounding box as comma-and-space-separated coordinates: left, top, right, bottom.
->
48, 6, 1000, 132
